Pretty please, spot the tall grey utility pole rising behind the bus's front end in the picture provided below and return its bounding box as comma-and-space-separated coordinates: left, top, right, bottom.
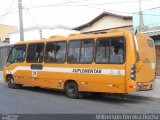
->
18, 0, 24, 41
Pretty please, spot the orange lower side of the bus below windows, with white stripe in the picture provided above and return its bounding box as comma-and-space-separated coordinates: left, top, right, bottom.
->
4, 63, 125, 93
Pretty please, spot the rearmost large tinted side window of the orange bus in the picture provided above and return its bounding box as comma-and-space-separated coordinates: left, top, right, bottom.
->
96, 37, 125, 63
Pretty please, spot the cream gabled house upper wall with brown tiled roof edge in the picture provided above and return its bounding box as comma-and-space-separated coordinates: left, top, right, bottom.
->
73, 12, 133, 33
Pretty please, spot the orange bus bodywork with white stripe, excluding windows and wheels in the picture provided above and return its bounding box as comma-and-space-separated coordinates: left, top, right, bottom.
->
4, 30, 155, 93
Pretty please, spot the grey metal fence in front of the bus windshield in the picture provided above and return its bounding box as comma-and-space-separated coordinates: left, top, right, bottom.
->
0, 45, 10, 70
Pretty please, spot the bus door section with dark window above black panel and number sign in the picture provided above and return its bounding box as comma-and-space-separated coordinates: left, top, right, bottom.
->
26, 43, 44, 86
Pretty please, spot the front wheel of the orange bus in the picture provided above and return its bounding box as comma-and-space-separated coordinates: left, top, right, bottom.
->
7, 75, 22, 89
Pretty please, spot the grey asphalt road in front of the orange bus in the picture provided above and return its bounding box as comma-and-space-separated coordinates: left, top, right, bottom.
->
0, 83, 160, 114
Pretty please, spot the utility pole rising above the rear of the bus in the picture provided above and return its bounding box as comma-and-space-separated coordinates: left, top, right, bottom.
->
139, 0, 144, 31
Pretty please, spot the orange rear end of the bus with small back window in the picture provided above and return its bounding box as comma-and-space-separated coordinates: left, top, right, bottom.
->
137, 33, 156, 90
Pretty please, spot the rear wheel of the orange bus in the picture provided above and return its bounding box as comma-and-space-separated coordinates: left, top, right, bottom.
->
66, 81, 79, 99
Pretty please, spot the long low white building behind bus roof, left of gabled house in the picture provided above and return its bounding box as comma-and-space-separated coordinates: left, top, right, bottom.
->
10, 25, 77, 44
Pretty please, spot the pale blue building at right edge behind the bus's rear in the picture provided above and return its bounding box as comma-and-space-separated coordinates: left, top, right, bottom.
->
133, 7, 160, 76
